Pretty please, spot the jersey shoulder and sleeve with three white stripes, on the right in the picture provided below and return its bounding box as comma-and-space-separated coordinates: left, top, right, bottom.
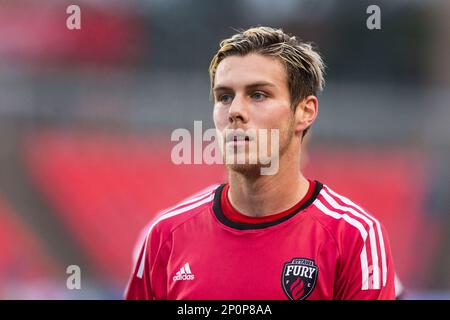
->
312, 181, 391, 290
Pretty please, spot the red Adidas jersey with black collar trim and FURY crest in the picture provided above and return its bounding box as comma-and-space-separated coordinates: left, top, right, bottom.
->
125, 181, 395, 300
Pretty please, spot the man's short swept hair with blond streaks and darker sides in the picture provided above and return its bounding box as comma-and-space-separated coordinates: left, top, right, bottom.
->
209, 27, 325, 108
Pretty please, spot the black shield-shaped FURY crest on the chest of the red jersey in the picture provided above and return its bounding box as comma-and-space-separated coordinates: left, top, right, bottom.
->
281, 258, 319, 300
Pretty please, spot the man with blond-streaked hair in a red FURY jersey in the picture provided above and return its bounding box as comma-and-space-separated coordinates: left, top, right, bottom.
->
126, 27, 395, 300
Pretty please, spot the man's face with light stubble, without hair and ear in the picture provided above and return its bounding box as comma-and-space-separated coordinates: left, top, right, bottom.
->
213, 54, 295, 174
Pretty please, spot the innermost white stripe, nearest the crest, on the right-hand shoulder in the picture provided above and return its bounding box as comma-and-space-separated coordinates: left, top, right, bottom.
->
313, 199, 369, 290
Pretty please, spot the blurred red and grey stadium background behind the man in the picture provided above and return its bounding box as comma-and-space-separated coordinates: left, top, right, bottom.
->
0, 0, 450, 299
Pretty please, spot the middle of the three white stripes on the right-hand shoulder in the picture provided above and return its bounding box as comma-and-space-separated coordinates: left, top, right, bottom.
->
320, 188, 380, 289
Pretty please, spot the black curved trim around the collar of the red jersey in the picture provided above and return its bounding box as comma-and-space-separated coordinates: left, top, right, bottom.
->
213, 180, 323, 230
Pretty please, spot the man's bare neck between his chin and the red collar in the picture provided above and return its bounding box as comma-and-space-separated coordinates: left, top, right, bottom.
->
228, 161, 309, 217
